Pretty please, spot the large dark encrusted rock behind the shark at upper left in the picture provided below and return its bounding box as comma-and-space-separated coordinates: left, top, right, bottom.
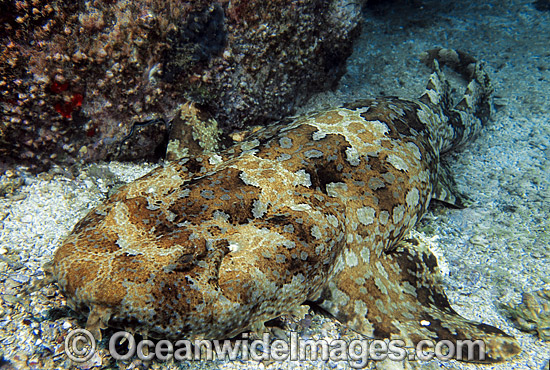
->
0, 0, 361, 170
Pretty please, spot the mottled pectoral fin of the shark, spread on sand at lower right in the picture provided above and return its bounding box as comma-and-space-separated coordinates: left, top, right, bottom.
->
319, 239, 520, 362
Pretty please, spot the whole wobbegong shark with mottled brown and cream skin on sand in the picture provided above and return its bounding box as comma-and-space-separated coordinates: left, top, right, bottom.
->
50, 49, 519, 361
